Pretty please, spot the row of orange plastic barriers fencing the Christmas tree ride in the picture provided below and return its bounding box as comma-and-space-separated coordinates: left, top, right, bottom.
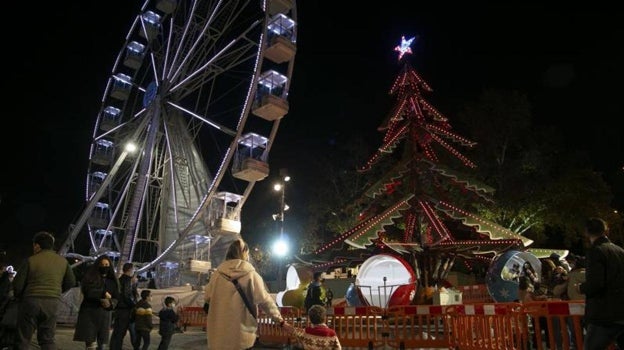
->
258, 301, 600, 350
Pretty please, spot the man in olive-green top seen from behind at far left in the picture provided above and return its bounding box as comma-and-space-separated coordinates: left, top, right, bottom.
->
13, 231, 76, 350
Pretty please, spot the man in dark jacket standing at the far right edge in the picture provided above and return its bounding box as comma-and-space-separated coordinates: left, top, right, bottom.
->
577, 218, 624, 350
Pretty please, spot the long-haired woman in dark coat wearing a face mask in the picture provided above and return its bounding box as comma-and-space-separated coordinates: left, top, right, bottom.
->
74, 255, 119, 350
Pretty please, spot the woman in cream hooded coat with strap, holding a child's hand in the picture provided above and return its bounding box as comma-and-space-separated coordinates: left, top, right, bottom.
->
204, 239, 292, 350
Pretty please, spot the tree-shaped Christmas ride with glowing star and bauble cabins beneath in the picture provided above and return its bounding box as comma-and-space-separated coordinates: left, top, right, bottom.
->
285, 37, 567, 307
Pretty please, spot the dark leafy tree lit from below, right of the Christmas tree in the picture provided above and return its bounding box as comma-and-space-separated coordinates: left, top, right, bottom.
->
458, 90, 621, 248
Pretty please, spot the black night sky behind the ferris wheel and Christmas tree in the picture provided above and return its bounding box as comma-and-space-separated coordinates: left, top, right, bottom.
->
0, 0, 624, 260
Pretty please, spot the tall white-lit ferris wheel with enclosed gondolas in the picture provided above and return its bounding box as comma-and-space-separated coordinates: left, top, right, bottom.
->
59, 0, 296, 286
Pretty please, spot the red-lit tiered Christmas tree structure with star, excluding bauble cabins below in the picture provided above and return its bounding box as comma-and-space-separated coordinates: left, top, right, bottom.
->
294, 37, 532, 298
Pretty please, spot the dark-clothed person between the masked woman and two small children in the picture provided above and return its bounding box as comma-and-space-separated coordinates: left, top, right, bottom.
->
110, 263, 139, 350
